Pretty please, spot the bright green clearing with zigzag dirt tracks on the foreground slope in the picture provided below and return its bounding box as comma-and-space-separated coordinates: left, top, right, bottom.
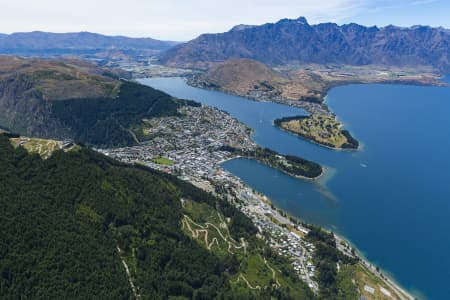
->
182, 200, 314, 299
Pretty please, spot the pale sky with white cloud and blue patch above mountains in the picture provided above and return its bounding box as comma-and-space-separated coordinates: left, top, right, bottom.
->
0, 0, 450, 41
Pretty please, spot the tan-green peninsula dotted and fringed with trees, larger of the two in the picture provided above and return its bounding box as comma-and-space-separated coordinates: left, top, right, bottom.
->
274, 114, 359, 149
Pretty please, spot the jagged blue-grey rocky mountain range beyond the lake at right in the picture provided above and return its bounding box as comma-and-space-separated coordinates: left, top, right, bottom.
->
161, 17, 450, 71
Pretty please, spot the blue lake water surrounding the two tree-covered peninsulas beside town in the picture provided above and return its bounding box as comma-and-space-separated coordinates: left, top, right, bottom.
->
141, 78, 450, 299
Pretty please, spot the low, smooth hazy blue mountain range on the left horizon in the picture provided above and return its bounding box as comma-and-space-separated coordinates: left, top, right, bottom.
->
0, 31, 177, 54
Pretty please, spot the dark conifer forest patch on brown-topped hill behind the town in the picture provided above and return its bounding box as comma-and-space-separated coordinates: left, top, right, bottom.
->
51, 81, 200, 147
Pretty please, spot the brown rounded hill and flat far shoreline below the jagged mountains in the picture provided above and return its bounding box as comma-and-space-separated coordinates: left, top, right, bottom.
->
189, 58, 444, 105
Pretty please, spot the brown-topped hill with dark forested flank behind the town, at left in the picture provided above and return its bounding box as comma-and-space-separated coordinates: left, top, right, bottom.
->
0, 56, 187, 146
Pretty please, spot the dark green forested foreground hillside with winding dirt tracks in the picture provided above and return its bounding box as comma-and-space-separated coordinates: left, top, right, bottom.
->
0, 135, 313, 299
